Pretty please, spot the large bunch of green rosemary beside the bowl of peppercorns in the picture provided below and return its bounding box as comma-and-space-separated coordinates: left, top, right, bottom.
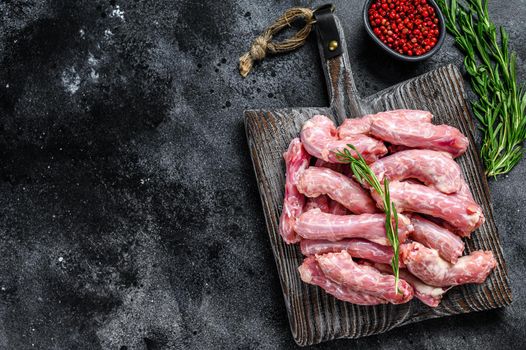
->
437, 0, 526, 176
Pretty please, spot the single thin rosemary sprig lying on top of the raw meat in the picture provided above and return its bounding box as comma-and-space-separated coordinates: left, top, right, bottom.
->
336, 144, 400, 293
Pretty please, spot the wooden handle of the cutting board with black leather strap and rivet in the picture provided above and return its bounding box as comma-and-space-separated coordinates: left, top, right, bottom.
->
315, 5, 362, 122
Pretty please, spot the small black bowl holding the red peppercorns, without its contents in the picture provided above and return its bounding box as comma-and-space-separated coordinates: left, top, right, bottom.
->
363, 0, 446, 62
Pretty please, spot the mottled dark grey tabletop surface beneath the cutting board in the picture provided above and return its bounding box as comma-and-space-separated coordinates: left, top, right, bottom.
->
0, 0, 526, 350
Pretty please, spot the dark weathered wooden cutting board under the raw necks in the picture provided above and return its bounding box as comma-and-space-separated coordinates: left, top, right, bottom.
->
245, 9, 511, 345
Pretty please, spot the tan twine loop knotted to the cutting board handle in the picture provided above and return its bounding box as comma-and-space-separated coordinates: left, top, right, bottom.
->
239, 7, 316, 77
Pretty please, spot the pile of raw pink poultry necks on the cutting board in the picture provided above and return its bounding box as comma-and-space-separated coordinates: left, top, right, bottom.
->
280, 110, 496, 307
